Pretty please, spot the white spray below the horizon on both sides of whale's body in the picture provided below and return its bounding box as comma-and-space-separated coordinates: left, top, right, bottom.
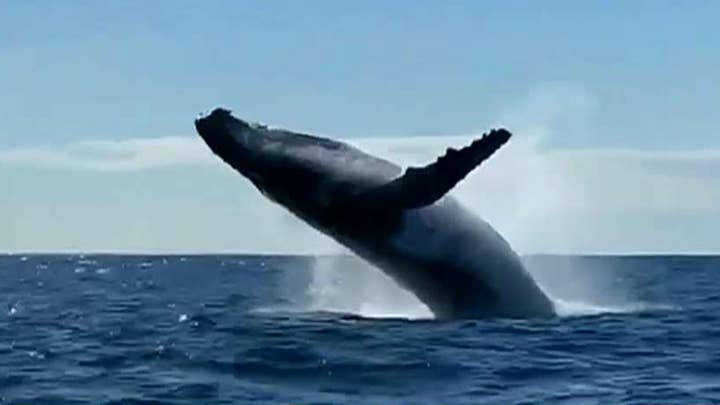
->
304, 255, 648, 319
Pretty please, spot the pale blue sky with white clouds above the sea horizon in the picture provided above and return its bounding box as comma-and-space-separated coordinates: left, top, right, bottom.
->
0, 0, 720, 253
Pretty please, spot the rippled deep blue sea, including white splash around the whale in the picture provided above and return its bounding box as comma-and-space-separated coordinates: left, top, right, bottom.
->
0, 255, 720, 404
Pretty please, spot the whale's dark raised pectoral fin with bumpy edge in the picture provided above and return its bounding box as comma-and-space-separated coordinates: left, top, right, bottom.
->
356, 129, 511, 209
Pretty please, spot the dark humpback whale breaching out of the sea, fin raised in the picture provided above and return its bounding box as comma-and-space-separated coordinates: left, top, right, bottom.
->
195, 108, 555, 319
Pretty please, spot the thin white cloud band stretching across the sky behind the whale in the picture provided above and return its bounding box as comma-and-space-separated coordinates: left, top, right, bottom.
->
0, 133, 720, 177
